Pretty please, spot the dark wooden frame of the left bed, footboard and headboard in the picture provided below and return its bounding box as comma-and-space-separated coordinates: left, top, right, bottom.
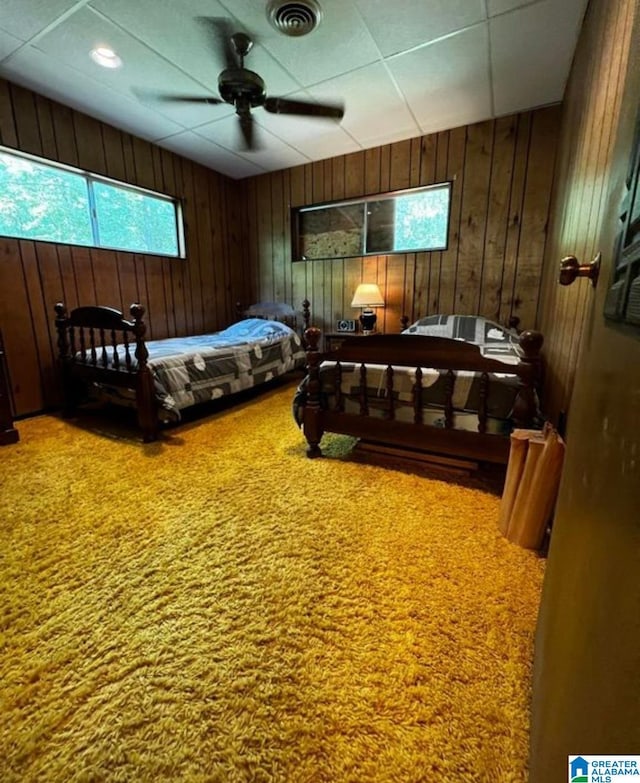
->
55, 299, 311, 443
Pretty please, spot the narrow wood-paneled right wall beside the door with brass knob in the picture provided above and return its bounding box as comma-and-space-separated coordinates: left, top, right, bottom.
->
538, 0, 637, 420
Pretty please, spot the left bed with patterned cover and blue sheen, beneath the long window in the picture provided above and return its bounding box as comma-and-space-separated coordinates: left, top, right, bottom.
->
55, 300, 310, 442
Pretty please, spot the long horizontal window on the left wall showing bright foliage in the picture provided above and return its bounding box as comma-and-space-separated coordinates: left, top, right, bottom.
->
0, 148, 184, 257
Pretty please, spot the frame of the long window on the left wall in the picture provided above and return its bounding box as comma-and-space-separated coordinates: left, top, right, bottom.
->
0, 144, 186, 259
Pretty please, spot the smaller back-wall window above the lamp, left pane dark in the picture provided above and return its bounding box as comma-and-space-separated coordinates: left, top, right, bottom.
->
293, 182, 451, 261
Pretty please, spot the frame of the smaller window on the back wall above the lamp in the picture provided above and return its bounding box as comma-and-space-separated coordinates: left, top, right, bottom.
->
291, 180, 453, 263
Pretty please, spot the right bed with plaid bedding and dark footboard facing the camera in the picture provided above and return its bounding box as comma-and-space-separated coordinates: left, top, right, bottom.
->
294, 315, 543, 464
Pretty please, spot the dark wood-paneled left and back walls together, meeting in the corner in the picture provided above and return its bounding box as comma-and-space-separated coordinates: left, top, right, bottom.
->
0, 80, 560, 422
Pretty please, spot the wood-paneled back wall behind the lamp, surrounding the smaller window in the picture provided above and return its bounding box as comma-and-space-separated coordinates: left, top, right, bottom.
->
236, 106, 560, 331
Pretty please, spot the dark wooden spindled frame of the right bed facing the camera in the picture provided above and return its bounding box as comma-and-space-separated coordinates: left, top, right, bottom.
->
303, 327, 543, 464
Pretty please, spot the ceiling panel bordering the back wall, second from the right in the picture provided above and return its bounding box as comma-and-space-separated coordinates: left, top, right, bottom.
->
388, 25, 492, 133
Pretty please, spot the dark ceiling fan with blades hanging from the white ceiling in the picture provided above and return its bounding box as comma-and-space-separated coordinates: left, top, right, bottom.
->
154, 18, 344, 150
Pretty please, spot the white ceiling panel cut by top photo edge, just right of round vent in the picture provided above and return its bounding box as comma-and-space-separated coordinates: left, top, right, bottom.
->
355, 0, 485, 57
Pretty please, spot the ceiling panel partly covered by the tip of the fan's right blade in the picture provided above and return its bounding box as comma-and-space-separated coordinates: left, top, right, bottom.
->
308, 63, 420, 147
